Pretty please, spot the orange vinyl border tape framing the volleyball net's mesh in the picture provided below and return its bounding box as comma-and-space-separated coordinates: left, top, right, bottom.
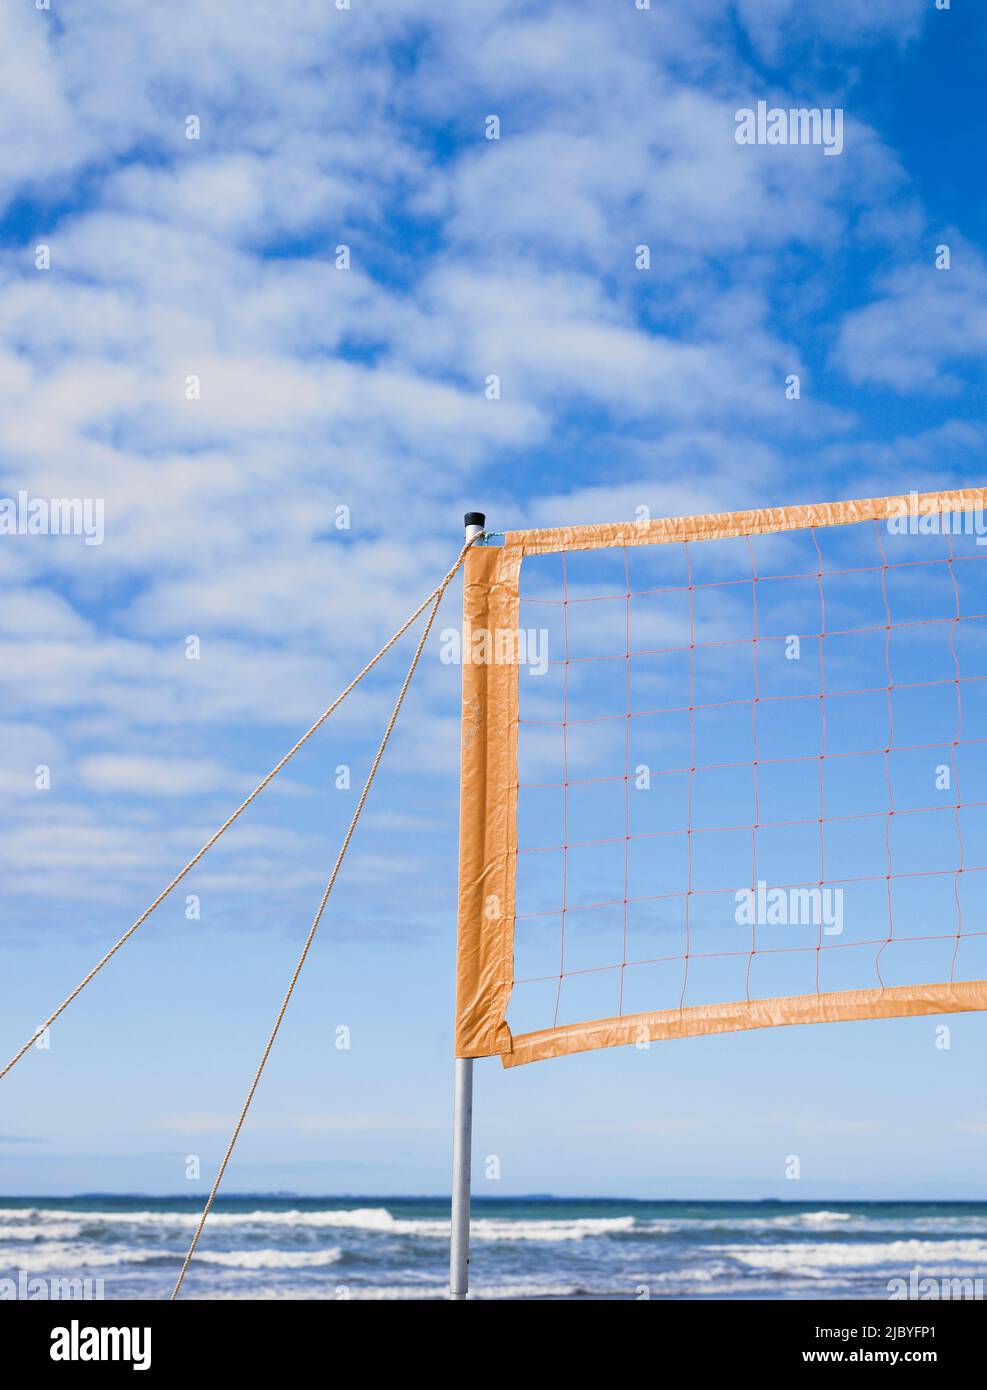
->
455, 488, 987, 1066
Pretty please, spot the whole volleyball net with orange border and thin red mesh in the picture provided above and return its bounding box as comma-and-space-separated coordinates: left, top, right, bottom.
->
456, 488, 987, 1066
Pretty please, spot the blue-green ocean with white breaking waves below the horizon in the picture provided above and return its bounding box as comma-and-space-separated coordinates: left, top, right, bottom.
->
0, 1195, 987, 1300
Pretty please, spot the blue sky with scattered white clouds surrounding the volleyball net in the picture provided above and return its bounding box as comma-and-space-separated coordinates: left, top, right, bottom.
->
0, 0, 987, 1198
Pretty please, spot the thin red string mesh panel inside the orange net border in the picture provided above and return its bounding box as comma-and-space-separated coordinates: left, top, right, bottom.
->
507, 513, 987, 1034
